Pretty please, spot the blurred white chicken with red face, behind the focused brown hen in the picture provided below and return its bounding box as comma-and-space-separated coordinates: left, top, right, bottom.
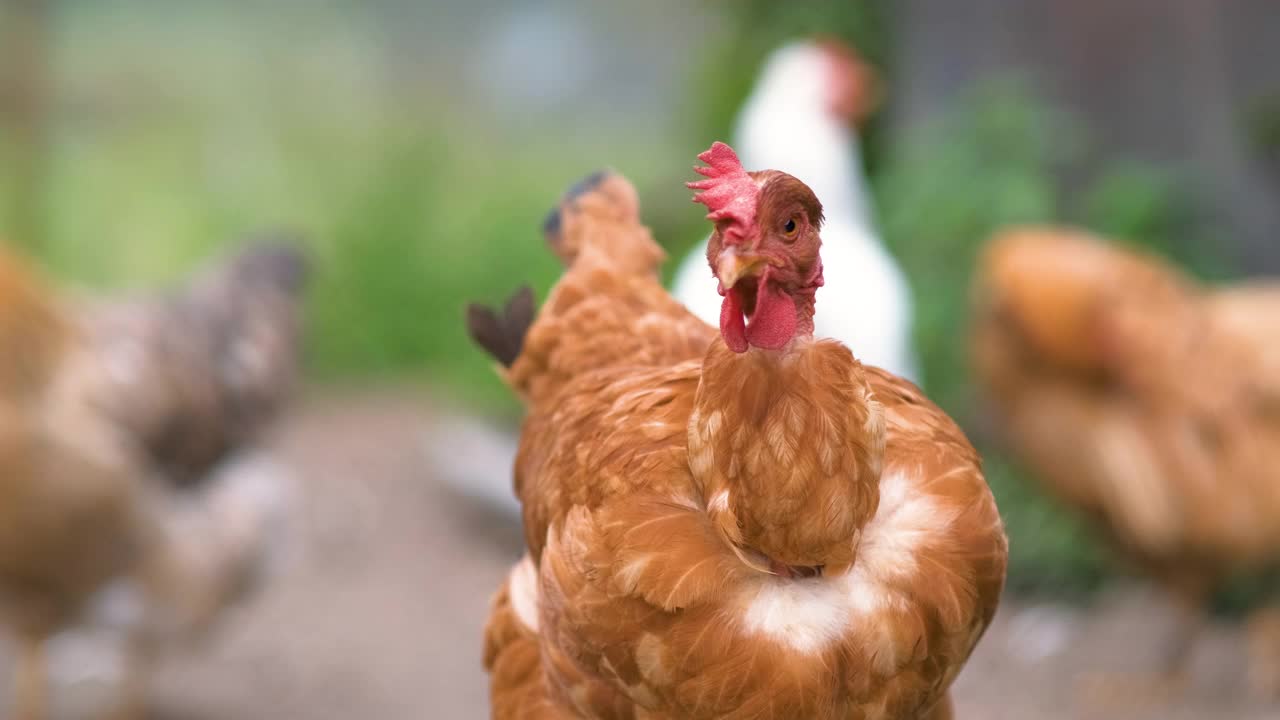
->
673, 41, 919, 380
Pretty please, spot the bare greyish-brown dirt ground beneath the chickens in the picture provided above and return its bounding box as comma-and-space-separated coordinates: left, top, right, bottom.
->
0, 392, 1280, 720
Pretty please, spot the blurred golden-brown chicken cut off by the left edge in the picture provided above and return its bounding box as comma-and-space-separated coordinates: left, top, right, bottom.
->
0, 245, 155, 720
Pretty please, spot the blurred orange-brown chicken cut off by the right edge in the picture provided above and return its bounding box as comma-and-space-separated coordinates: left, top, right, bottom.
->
972, 227, 1280, 692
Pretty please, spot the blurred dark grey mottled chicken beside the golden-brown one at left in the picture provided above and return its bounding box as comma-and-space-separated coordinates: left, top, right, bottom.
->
83, 243, 307, 486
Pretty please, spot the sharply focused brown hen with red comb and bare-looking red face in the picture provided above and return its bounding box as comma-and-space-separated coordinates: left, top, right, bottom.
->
472, 143, 1006, 720
